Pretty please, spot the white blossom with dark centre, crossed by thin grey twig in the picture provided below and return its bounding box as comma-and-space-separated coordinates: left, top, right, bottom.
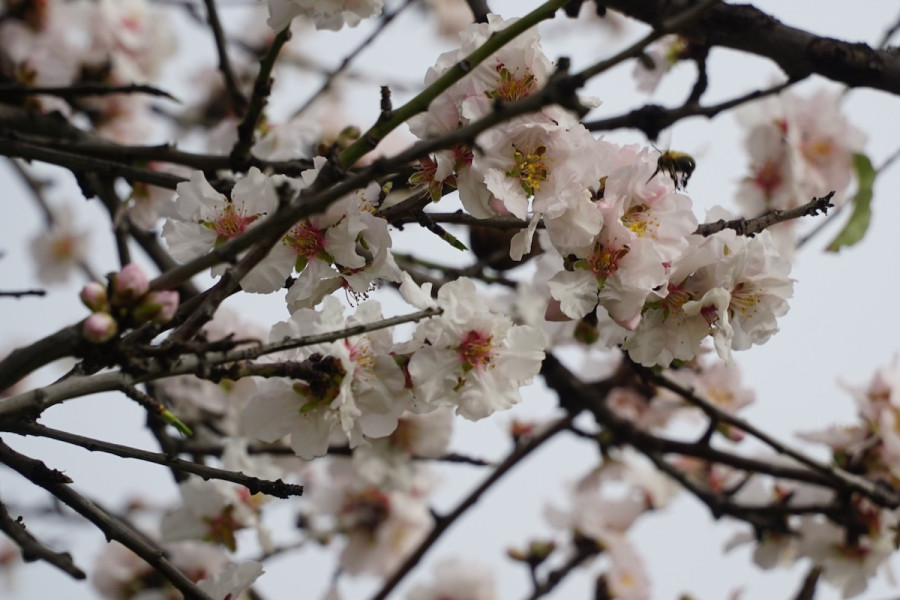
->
243, 296, 409, 459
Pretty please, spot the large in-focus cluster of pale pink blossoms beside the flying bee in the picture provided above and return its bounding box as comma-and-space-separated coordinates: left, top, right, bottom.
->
411, 19, 791, 366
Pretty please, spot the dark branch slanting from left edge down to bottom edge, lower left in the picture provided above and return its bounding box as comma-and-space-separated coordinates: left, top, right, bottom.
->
0, 440, 214, 600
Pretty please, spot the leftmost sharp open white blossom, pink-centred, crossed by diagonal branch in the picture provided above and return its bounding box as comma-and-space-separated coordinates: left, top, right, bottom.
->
162, 167, 291, 293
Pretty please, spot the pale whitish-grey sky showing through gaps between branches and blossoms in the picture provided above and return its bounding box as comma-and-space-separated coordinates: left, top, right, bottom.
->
0, 0, 900, 600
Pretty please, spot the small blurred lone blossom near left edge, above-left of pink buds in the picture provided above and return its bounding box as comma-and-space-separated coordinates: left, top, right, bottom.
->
30, 204, 89, 284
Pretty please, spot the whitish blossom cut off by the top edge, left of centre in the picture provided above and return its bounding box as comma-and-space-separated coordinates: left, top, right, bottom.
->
268, 0, 384, 31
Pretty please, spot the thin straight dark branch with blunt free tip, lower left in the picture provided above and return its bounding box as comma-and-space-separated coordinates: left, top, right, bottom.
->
7, 423, 303, 498
